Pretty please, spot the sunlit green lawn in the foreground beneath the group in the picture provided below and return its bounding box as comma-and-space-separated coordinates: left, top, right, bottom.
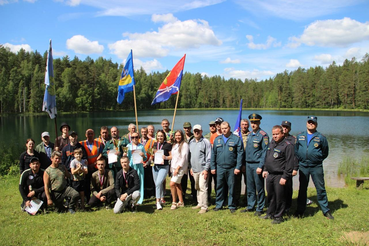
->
0, 177, 369, 245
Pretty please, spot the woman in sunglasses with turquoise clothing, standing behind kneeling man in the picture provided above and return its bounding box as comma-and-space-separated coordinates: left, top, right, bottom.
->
124, 132, 146, 205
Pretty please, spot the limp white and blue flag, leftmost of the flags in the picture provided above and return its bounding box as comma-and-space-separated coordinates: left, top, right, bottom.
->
42, 39, 57, 119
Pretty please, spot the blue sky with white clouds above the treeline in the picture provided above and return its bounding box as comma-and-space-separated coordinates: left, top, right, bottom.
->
0, 0, 369, 80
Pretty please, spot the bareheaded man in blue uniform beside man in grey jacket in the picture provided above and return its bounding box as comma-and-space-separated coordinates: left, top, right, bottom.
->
210, 121, 243, 213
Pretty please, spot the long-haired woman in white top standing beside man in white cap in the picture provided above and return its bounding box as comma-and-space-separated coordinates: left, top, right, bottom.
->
170, 130, 189, 209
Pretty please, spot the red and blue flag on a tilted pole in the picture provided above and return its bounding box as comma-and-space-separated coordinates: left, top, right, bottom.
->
151, 55, 186, 105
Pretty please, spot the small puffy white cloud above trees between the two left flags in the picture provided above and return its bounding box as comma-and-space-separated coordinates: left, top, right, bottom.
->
67, 35, 104, 55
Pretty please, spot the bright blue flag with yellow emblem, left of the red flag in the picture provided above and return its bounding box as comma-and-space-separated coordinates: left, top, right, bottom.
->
117, 50, 136, 104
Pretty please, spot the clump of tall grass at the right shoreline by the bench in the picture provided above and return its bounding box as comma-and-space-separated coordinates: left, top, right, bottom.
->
338, 156, 369, 185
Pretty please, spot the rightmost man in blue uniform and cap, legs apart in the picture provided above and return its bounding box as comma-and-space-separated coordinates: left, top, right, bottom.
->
295, 116, 334, 219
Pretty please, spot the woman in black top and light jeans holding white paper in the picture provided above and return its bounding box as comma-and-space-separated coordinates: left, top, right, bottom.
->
151, 130, 172, 210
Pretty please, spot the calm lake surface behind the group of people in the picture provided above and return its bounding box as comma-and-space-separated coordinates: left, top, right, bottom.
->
0, 110, 369, 187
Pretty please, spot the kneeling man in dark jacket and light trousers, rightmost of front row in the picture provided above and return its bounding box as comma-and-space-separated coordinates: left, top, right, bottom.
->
114, 156, 141, 214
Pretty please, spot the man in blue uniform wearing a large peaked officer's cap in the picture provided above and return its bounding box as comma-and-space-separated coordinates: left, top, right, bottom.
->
241, 114, 269, 216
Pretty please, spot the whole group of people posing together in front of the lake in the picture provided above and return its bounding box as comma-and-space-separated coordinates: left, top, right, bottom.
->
19, 114, 333, 224
